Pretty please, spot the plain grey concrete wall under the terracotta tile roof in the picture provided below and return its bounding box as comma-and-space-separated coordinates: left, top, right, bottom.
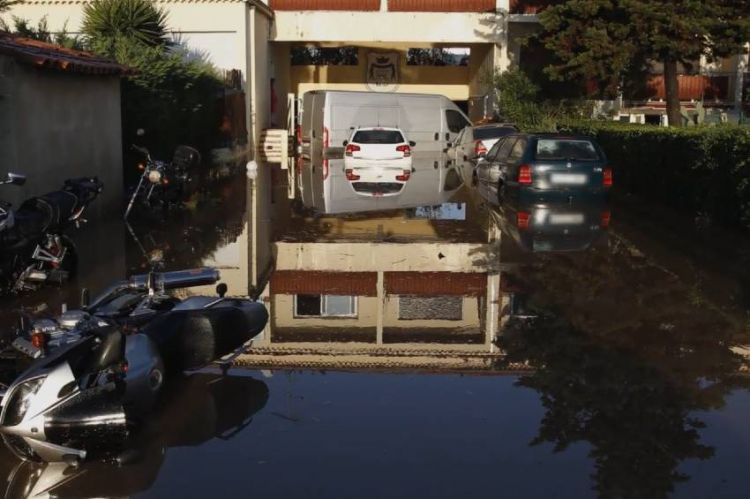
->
0, 56, 123, 218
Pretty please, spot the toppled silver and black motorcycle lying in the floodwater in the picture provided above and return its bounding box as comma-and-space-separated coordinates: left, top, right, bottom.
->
0, 269, 268, 464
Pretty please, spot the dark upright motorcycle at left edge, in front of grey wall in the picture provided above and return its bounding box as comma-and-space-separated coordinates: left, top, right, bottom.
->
0, 173, 102, 294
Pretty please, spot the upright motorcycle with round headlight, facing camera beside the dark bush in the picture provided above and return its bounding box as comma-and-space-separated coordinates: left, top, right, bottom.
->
123, 144, 201, 220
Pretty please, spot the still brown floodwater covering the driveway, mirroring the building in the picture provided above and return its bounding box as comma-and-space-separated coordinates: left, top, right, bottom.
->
0, 165, 750, 498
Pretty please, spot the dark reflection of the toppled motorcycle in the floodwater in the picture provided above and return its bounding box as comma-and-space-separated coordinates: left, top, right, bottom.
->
0, 373, 268, 497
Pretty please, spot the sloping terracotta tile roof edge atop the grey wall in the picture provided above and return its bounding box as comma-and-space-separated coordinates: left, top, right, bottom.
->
0, 32, 133, 75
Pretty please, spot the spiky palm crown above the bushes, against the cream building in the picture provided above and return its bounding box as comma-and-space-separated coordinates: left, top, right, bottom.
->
82, 0, 169, 53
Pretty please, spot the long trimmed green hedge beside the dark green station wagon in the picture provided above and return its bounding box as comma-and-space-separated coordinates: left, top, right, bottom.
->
564, 122, 750, 228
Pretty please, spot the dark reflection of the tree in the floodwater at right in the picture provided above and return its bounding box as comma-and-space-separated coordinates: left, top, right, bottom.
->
499, 236, 748, 498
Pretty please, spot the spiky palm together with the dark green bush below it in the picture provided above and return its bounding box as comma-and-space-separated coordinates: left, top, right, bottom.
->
82, 0, 221, 156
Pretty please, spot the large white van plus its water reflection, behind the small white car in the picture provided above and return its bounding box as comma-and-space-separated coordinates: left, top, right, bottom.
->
296, 90, 471, 213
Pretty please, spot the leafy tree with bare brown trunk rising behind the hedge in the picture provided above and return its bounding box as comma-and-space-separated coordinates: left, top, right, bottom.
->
538, 0, 750, 126
